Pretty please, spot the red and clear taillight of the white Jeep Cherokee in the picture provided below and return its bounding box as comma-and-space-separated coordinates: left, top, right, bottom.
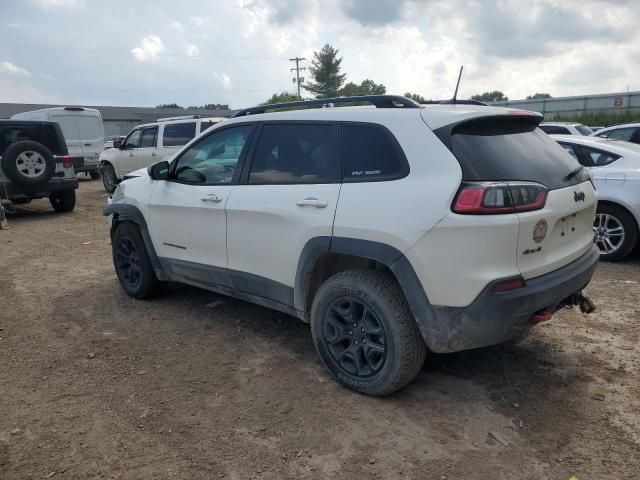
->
452, 182, 547, 215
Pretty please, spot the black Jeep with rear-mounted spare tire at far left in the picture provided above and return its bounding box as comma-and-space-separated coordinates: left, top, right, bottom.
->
0, 120, 78, 212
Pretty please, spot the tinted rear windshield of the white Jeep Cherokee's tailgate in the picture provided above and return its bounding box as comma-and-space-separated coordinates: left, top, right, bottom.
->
436, 117, 583, 189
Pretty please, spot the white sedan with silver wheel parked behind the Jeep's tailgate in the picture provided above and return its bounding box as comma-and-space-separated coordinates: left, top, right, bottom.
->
553, 135, 640, 260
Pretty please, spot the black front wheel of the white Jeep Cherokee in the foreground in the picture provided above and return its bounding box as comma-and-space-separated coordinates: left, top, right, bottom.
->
111, 222, 162, 299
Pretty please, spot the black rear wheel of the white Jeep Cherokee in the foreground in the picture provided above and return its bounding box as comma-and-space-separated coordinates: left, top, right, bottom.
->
311, 270, 427, 396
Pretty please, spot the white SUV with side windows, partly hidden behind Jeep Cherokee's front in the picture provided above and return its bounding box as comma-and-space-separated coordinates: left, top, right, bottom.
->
100, 117, 224, 193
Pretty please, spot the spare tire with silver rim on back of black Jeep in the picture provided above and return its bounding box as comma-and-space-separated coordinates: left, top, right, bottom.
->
2, 141, 56, 187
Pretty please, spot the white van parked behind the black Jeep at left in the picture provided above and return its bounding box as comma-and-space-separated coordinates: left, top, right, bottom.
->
11, 107, 104, 180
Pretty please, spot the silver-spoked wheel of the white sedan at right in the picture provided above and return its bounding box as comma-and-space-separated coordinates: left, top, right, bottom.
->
593, 204, 638, 262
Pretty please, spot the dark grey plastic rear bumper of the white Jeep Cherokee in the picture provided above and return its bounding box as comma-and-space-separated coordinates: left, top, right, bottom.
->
425, 245, 600, 352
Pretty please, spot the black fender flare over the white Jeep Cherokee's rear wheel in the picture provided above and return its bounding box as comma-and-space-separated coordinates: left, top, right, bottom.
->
294, 236, 448, 351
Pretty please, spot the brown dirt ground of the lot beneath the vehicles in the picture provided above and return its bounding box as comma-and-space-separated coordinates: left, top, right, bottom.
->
0, 180, 640, 480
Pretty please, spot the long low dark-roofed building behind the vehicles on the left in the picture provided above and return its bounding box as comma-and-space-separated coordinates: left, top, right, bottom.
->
0, 103, 233, 136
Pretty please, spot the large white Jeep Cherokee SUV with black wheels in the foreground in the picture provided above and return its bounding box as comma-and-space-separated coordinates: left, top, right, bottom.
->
105, 96, 599, 395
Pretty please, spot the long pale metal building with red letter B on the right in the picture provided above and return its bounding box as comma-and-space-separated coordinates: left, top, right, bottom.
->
491, 92, 640, 120
